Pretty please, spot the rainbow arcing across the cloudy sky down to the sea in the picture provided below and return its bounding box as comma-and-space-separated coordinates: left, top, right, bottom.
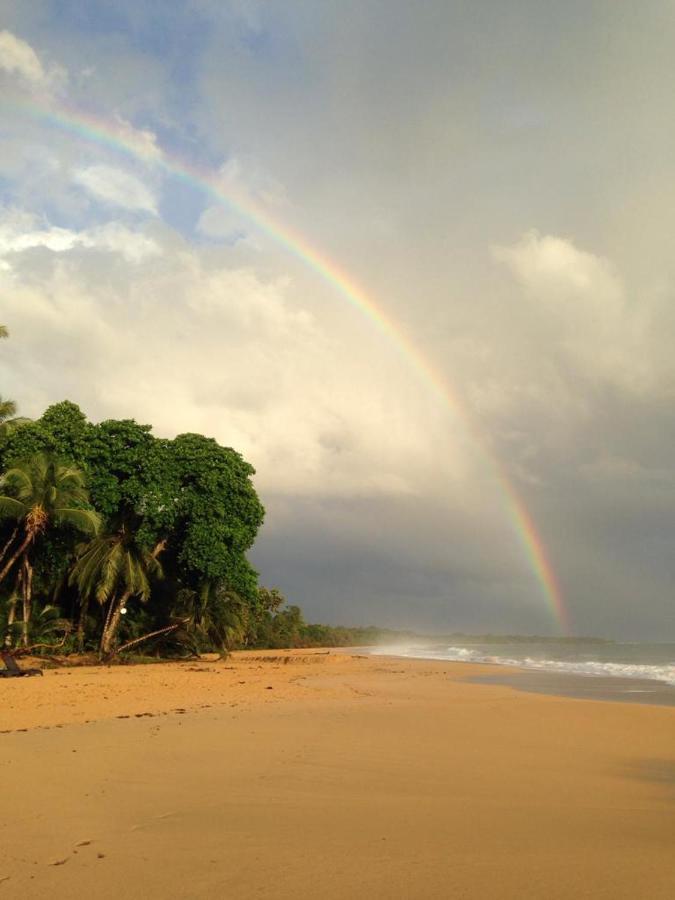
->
6, 100, 570, 634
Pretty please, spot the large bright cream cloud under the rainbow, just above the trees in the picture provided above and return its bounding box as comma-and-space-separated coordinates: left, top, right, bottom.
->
0, 227, 456, 496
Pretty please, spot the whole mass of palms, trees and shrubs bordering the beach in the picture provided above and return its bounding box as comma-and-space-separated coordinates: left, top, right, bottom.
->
0, 326, 386, 658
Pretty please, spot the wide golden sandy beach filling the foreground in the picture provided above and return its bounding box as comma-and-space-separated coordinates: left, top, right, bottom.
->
0, 651, 675, 900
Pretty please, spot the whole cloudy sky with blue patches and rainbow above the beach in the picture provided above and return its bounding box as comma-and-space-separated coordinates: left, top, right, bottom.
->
0, 0, 675, 640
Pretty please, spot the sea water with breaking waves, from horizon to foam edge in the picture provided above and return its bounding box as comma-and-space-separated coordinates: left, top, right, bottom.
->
373, 639, 675, 686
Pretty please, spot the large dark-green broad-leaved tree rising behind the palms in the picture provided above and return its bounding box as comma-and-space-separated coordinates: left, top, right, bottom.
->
0, 401, 264, 652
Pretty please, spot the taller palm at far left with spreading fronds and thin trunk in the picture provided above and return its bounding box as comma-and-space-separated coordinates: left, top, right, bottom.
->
0, 453, 99, 646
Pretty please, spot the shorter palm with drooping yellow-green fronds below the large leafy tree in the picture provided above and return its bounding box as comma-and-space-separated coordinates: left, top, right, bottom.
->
70, 525, 165, 657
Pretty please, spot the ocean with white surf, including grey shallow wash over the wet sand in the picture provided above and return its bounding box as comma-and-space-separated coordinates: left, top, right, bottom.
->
373, 638, 675, 705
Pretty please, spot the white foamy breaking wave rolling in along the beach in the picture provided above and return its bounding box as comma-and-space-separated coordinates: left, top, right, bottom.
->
373, 646, 675, 686
